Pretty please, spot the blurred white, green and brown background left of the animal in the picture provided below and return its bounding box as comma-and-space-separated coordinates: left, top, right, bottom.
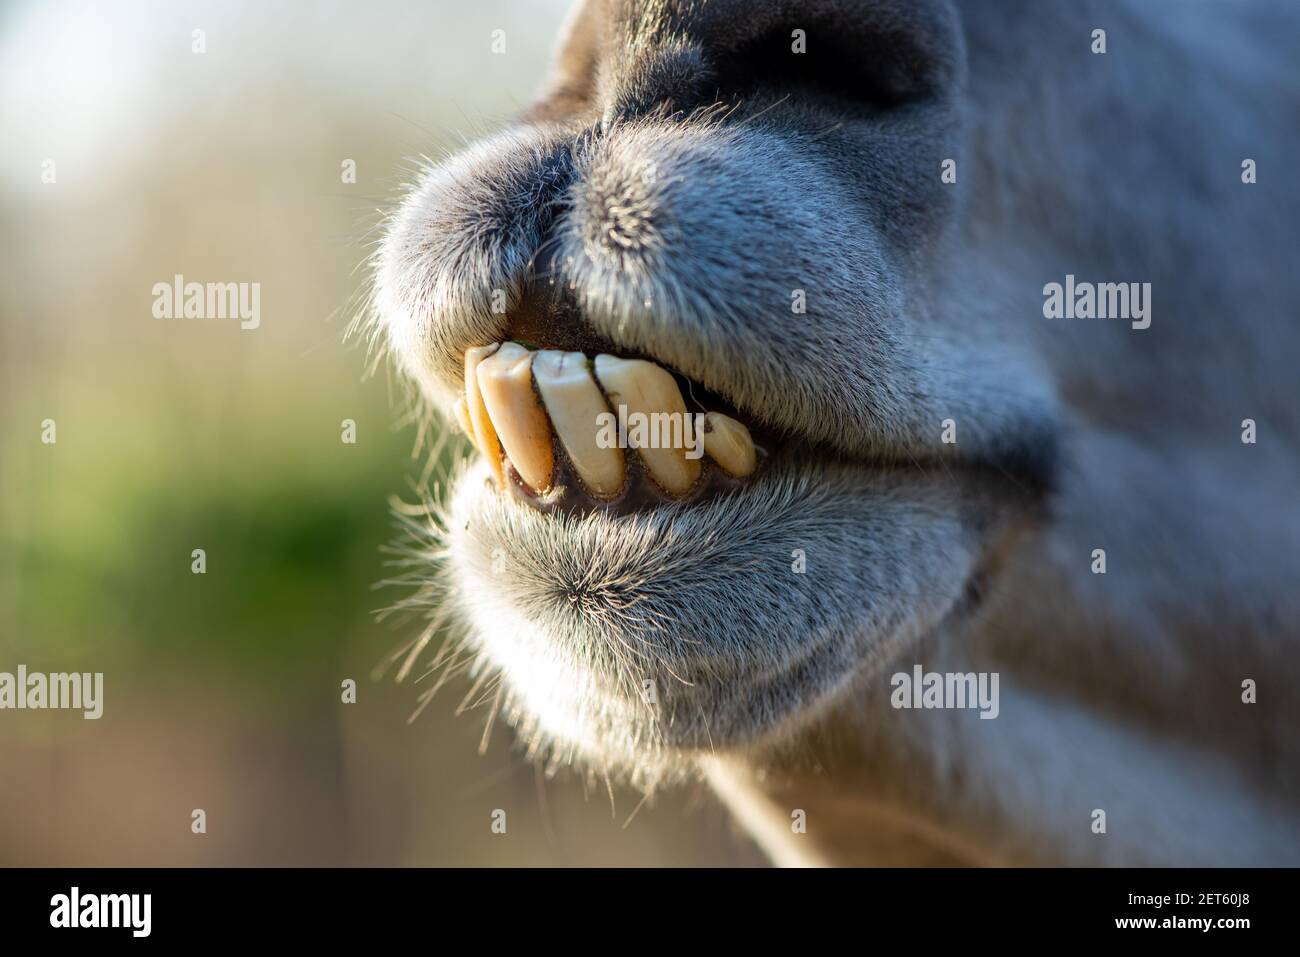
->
0, 0, 761, 865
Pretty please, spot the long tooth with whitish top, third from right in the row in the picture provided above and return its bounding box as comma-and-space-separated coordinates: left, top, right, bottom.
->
533, 350, 627, 498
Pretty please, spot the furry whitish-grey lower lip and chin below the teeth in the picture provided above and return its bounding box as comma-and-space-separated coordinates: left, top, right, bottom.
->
439, 438, 1019, 766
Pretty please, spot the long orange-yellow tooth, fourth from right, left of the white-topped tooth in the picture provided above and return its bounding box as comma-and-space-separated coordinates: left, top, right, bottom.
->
478, 342, 555, 492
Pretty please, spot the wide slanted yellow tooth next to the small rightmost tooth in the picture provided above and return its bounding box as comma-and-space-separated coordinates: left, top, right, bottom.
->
595, 355, 701, 495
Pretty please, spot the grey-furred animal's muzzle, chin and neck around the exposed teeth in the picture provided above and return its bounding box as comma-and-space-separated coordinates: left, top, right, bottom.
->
373, 0, 1300, 865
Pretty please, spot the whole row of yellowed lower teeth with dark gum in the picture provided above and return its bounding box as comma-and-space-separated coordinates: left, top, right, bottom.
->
452, 342, 766, 511
